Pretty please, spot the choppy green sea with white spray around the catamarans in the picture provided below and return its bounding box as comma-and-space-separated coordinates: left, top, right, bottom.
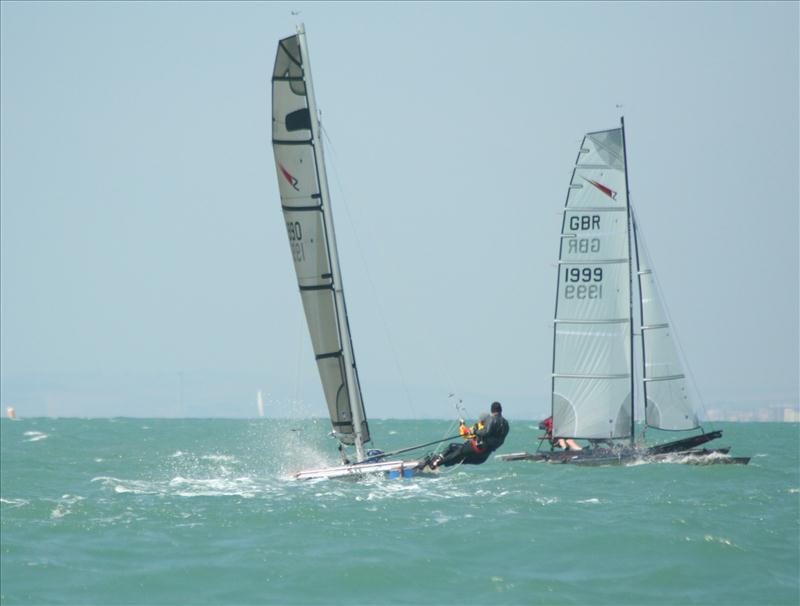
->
0, 418, 800, 606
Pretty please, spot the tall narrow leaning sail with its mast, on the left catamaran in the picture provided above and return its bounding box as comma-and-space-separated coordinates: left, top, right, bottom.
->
272, 26, 370, 460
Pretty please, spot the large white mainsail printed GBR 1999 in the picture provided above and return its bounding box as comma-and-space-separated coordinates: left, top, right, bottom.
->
552, 128, 632, 439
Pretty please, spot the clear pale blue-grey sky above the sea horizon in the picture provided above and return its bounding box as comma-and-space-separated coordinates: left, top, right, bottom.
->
0, 1, 800, 418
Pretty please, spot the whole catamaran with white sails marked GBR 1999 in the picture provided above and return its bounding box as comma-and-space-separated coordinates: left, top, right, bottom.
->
497, 120, 749, 465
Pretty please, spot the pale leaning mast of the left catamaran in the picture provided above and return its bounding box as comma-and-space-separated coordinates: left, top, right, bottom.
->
297, 23, 364, 461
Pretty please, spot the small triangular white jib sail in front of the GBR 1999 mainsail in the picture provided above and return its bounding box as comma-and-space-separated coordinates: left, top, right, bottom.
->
633, 220, 700, 431
